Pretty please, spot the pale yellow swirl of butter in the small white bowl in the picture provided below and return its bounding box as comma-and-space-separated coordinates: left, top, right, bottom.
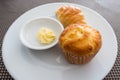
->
37, 27, 56, 44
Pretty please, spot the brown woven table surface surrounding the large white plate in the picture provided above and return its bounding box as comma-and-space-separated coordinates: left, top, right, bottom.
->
0, 0, 120, 80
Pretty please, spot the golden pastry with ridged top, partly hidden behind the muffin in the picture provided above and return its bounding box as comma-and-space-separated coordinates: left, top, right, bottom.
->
56, 6, 86, 27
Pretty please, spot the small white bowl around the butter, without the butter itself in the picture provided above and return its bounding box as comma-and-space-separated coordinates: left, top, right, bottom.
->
20, 17, 64, 50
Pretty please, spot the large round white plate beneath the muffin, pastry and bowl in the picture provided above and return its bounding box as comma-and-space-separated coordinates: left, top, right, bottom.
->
2, 3, 117, 80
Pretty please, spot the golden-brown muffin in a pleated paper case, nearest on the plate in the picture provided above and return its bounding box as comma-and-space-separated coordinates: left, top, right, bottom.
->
59, 24, 102, 64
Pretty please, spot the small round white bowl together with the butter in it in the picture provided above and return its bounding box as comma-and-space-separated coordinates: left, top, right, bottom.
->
20, 17, 64, 50
